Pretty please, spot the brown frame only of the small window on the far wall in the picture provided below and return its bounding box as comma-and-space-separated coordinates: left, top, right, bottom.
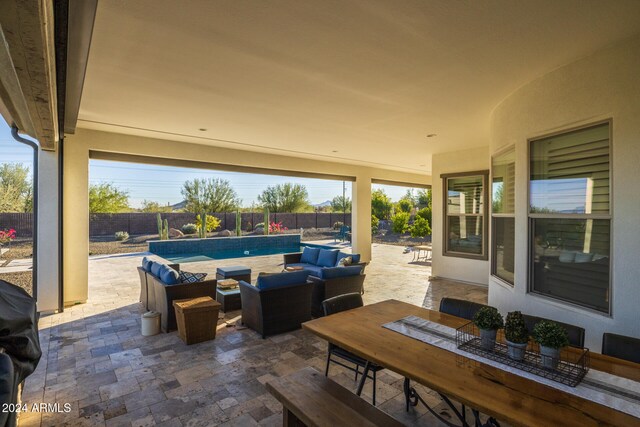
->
440, 170, 489, 261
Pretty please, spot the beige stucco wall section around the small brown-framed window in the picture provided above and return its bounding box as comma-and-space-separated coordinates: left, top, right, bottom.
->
431, 147, 490, 285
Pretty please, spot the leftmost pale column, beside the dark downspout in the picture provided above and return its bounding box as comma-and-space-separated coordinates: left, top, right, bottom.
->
34, 150, 59, 313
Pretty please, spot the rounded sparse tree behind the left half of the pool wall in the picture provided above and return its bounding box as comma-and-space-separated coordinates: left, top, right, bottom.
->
182, 178, 240, 213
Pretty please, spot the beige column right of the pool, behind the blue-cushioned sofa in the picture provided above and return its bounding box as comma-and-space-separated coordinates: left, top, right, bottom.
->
351, 175, 371, 261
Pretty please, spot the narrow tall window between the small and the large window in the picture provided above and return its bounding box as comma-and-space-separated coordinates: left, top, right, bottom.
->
491, 147, 516, 286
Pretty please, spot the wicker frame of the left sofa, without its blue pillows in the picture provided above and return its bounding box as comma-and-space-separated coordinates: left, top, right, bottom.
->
147, 265, 217, 332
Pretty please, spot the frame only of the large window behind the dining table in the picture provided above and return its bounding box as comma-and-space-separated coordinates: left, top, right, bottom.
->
526, 118, 614, 317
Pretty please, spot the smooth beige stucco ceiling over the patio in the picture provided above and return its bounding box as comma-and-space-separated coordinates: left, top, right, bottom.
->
78, 0, 640, 173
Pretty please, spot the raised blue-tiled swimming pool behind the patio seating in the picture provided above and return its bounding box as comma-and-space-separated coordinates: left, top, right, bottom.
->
149, 234, 332, 263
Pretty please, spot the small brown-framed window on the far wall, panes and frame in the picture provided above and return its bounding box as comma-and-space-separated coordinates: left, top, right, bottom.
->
442, 172, 488, 259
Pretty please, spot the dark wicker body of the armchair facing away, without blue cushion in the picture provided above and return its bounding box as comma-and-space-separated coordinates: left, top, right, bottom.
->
239, 280, 313, 338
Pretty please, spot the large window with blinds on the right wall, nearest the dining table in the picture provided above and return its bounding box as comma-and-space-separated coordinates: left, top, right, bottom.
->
529, 122, 611, 313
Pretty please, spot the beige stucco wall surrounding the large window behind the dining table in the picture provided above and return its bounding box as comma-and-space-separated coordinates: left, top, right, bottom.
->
489, 37, 640, 351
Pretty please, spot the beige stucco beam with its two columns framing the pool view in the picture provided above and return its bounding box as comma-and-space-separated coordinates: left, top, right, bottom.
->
63, 129, 431, 304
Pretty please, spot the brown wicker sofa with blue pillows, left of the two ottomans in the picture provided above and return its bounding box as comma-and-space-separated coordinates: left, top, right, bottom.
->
138, 261, 217, 332
